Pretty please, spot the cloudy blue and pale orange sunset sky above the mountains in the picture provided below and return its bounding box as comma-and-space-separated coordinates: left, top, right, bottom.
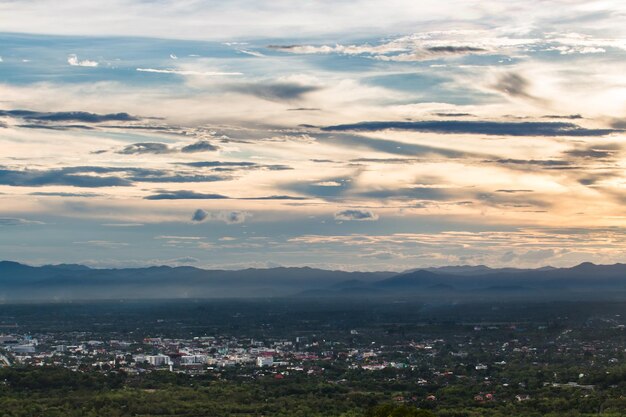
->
0, 0, 626, 271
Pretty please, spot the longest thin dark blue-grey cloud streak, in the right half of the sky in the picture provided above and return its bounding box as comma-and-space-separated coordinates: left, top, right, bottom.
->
322, 120, 621, 136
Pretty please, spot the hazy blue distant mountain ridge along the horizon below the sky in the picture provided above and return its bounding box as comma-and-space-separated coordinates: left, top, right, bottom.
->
0, 261, 626, 302
